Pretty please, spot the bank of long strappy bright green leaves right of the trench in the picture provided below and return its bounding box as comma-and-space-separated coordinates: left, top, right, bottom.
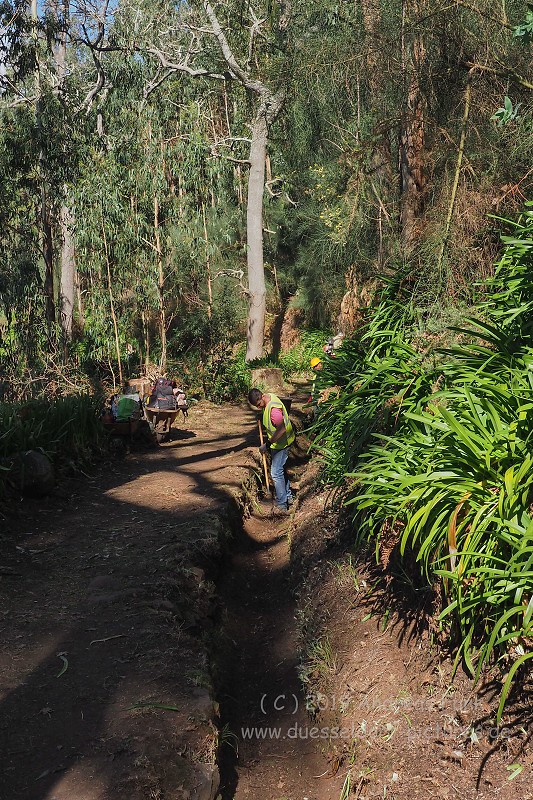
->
314, 204, 533, 721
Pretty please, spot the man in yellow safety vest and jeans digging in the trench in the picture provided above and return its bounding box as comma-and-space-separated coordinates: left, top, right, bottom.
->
248, 389, 294, 513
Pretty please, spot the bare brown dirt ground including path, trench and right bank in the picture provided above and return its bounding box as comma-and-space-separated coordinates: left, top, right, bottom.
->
0, 404, 533, 800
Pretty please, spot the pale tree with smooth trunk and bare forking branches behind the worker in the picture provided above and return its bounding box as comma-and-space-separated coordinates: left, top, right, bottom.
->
92, 0, 291, 360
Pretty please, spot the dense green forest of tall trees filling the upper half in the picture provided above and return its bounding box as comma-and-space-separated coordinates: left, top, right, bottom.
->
0, 0, 533, 393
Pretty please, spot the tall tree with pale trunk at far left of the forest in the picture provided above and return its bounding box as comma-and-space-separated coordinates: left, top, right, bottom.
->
0, 0, 96, 351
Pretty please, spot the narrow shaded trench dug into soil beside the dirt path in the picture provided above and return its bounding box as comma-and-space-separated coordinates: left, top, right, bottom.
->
212, 482, 338, 800
